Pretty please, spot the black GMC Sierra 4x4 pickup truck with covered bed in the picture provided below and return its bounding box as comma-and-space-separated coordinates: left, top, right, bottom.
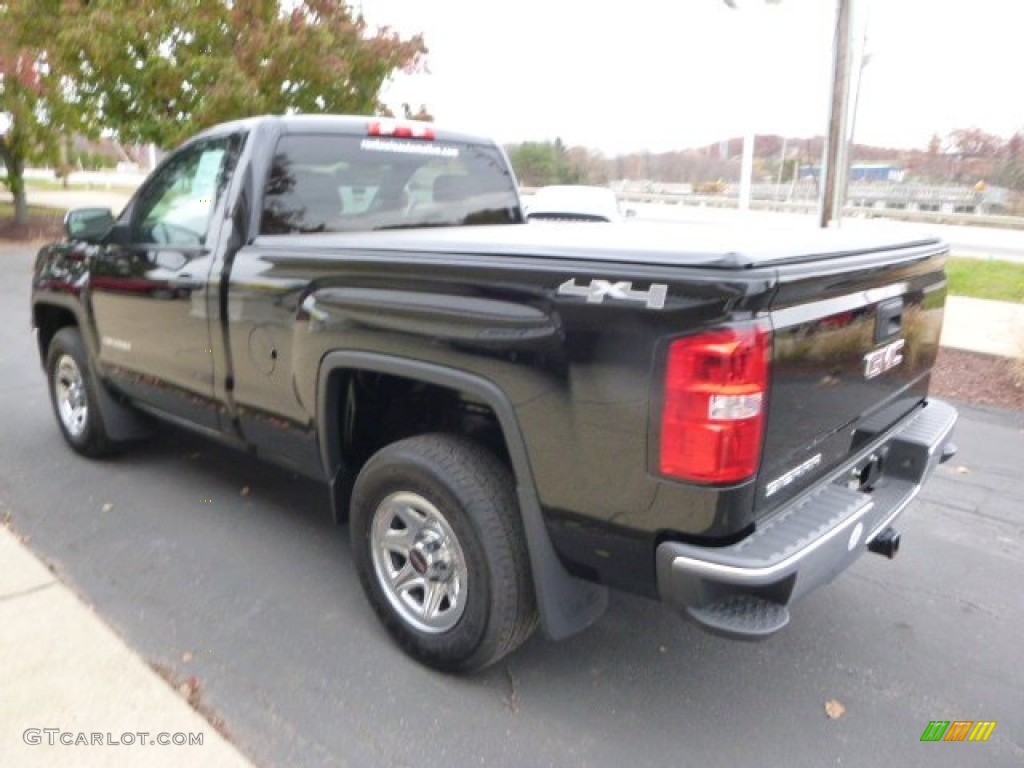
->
32, 116, 956, 671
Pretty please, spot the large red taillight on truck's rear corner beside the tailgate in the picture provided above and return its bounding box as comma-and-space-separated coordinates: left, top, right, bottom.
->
658, 325, 771, 482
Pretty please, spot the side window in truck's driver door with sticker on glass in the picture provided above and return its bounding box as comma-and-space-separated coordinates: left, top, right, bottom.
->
132, 135, 243, 247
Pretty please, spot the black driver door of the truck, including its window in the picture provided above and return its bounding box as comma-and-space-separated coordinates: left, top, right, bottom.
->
90, 134, 243, 429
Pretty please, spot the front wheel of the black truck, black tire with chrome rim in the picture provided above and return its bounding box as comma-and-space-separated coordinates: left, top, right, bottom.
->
46, 328, 114, 457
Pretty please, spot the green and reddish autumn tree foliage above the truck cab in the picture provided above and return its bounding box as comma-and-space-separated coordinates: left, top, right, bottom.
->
0, 0, 427, 227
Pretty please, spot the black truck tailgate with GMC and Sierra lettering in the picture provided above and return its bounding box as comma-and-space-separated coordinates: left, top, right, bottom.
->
755, 242, 946, 517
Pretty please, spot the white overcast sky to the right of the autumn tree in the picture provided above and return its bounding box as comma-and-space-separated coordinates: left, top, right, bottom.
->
368, 0, 1024, 153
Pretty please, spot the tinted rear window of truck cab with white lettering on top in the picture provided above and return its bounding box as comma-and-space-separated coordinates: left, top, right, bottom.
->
260, 134, 522, 234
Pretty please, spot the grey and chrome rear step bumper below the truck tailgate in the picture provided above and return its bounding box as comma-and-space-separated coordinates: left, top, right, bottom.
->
656, 400, 956, 639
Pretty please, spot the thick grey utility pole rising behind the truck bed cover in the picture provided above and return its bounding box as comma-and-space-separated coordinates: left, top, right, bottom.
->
820, 0, 853, 227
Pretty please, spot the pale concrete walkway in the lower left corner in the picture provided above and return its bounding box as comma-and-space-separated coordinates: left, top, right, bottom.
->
0, 525, 252, 768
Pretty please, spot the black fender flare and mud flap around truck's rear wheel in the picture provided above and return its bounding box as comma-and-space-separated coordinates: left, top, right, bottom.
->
316, 351, 608, 640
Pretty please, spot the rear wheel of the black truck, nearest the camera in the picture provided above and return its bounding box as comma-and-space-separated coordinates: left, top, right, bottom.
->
351, 434, 537, 672
